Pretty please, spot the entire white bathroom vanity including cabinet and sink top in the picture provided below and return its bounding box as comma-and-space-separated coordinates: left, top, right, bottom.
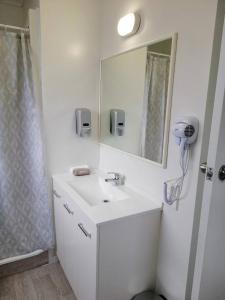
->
53, 173, 161, 300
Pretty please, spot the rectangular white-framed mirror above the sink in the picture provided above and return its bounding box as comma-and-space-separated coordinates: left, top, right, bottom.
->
100, 34, 177, 168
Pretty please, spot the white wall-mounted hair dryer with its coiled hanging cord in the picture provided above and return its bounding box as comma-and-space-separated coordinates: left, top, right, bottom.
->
164, 117, 199, 205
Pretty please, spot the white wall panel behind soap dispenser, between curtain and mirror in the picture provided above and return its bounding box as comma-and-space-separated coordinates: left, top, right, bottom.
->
40, 0, 99, 173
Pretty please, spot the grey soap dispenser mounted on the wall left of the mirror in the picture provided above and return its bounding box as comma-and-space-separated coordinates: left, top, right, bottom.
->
75, 108, 91, 137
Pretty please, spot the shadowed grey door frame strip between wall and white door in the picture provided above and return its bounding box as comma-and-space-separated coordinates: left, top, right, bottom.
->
185, 6, 225, 300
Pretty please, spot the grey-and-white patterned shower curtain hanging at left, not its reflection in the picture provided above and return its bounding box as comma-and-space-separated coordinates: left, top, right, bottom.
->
0, 32, 53, 259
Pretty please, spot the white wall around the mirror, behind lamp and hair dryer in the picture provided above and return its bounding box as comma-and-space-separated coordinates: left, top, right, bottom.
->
97, 0, 217, 300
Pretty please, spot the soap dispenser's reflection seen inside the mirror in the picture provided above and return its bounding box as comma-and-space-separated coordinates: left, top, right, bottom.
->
110, 109, 125, 136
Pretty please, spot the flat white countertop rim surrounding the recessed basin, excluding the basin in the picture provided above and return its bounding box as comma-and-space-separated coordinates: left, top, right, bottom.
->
53, 171, 162, 225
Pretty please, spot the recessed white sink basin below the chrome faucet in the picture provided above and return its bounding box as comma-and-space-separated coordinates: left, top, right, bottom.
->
68, 174, 129, 206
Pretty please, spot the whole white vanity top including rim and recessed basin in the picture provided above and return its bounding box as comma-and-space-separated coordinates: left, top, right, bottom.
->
53, 170, 162, 224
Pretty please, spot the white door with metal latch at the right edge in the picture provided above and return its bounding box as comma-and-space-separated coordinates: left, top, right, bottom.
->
192, 18, 225, 300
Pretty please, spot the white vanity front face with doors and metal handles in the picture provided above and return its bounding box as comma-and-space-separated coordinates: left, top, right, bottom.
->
54, 183, 97, 300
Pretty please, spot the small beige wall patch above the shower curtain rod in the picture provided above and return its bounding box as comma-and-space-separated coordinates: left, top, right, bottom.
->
0, 3, 24, 26
